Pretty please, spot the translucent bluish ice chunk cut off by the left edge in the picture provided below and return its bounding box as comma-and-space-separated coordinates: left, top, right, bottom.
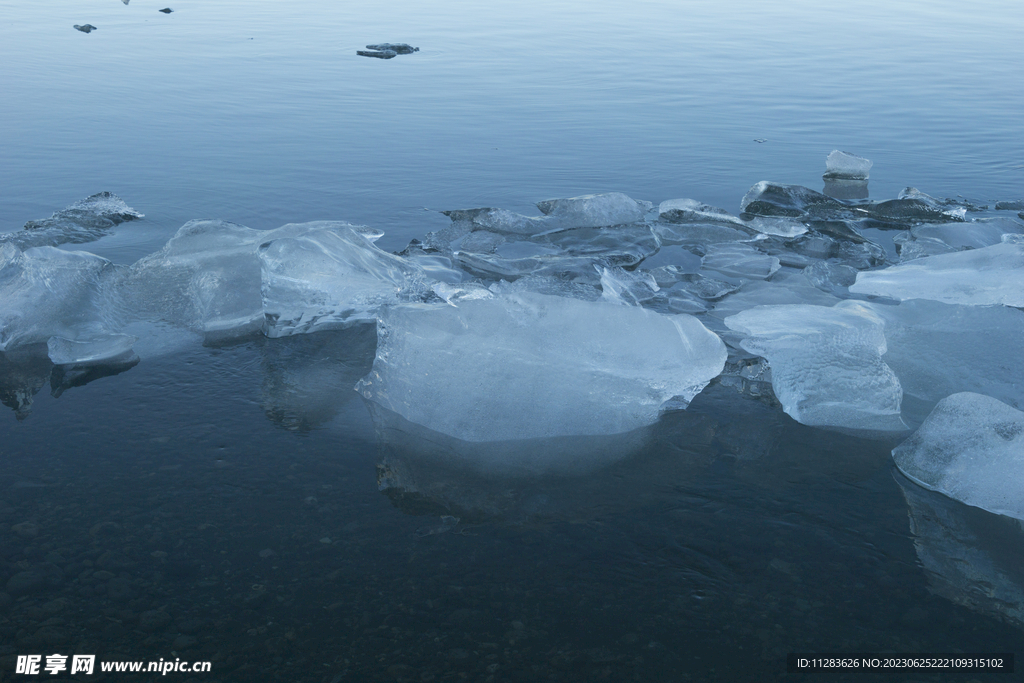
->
0, 244, 117, 351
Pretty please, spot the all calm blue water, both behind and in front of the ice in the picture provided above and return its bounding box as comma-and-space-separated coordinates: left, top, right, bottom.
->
0, 0, 1024, 683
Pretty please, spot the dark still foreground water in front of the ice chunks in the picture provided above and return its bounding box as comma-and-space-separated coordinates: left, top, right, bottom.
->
0, 339, 1021, 683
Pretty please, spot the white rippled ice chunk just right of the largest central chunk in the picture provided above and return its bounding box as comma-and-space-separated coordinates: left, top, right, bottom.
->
725, 302, 906, 431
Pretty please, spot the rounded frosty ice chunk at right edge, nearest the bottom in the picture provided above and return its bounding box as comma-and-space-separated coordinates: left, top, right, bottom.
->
893, 392, 1024, 519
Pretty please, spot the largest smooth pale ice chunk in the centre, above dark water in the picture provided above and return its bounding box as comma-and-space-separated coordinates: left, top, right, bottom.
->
356, 293, 726, 441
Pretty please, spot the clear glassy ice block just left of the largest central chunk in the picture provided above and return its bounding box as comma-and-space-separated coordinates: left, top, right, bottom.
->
257, 227, 430, 337
